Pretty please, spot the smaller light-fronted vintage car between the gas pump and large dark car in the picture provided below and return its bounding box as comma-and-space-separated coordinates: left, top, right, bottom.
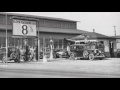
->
53, 50, 70, 59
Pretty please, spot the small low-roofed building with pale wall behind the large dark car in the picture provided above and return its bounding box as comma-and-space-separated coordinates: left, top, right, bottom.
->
71, 31, 117, 57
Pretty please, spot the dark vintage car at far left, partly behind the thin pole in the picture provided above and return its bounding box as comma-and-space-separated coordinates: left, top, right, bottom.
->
0, 47, 20, 63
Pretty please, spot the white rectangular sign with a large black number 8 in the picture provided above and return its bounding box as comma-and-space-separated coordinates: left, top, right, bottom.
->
13, 19, 36, 36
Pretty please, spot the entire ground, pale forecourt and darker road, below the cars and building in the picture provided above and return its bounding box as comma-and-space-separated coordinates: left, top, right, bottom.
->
0, 58, 120, 78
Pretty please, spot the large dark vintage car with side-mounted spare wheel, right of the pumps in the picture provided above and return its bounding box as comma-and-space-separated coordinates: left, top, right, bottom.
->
70, 44, 105, 60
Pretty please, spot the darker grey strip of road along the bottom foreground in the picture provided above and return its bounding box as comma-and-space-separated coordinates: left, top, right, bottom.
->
0, 69, 120, 78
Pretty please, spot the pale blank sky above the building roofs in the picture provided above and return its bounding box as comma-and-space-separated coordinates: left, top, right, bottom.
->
10, 12, 120, 36
